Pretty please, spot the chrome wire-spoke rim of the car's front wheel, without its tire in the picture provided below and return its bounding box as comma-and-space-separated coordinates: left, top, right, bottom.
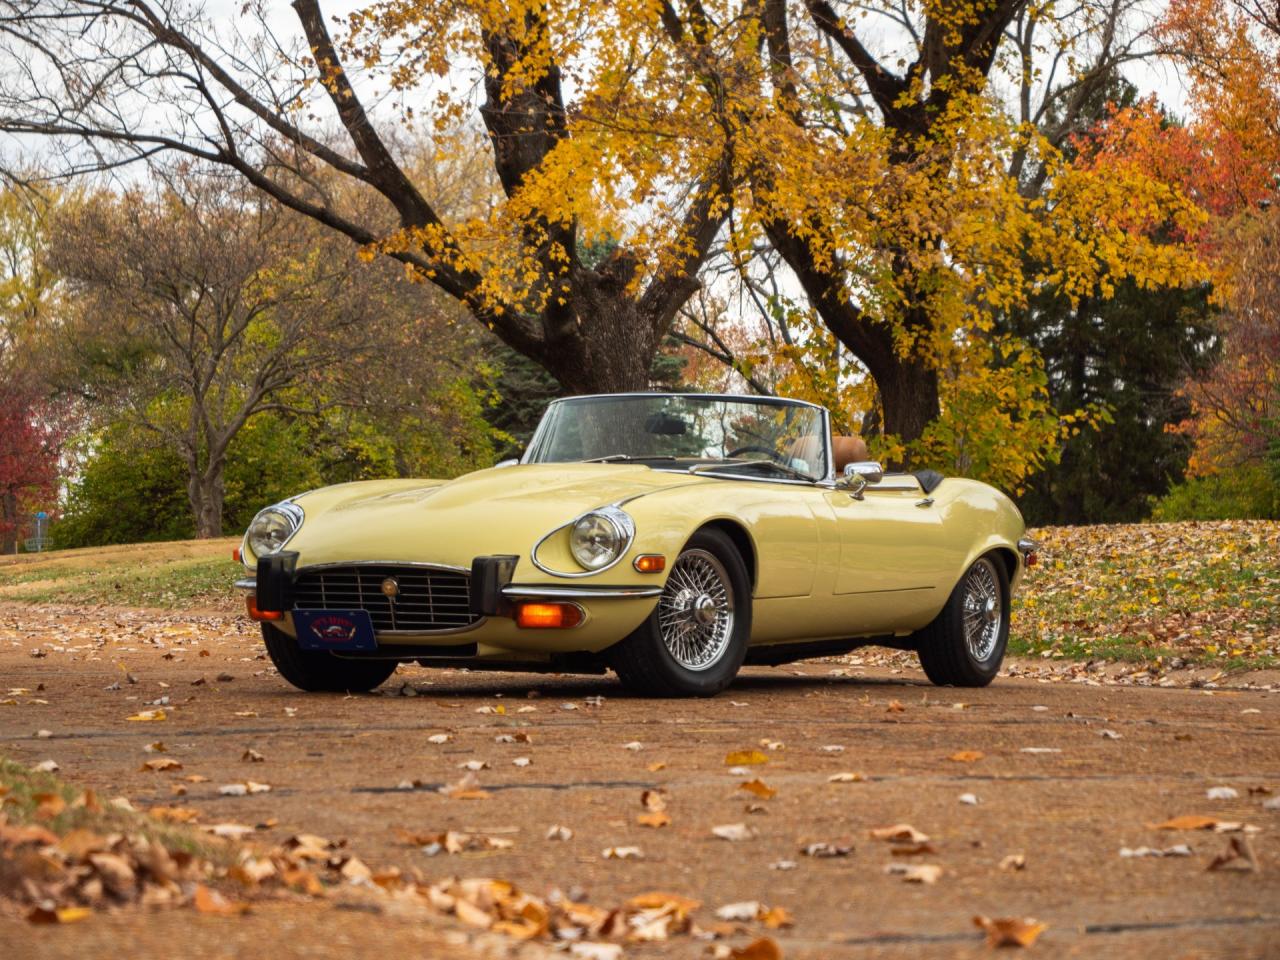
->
658, 548, 733, 671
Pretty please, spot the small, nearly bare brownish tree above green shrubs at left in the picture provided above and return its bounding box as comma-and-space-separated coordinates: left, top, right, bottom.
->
50, 172, 481, 536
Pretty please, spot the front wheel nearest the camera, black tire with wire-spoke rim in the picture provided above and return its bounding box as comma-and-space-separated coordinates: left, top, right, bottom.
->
611, 529, 751, 696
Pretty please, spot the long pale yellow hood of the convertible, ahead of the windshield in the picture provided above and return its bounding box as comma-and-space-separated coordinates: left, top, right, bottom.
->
288, 463, 712, 567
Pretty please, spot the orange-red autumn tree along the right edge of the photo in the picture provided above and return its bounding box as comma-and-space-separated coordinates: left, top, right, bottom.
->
1088, 0, 1280, 488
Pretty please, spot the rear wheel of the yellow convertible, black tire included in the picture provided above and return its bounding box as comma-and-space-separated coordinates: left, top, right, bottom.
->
915, 553, 1009, 686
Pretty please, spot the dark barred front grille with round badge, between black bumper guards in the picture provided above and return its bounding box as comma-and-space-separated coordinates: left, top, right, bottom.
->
293, 563, 479, 632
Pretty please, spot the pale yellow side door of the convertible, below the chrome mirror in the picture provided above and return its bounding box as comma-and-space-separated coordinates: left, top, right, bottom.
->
827, 474, 959, 634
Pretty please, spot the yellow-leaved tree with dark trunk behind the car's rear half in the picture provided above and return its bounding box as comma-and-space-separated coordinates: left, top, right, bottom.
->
727, 0, 1196, 473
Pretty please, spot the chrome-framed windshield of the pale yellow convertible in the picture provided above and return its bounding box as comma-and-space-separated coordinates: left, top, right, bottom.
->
525, 393, 827, 480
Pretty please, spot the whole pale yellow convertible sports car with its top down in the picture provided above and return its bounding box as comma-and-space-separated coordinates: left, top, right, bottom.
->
237, 393, 1034, 696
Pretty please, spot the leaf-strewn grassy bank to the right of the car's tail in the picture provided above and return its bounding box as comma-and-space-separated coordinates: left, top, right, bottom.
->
1010, 521, 1280, 668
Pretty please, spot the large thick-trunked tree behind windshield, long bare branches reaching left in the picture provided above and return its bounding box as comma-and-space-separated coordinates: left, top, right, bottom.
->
0, 0, 736, 392
